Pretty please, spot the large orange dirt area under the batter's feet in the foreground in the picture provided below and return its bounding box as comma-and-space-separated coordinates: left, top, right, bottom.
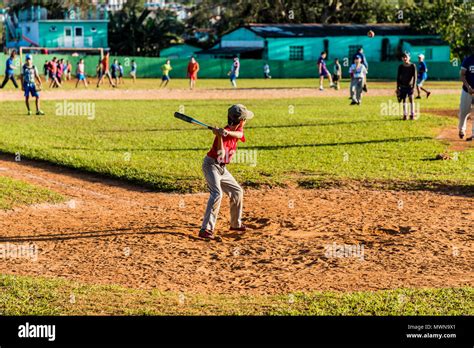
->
0, 156, 474, 294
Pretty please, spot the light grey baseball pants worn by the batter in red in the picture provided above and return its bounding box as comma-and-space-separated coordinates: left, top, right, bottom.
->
201, 156, 244, 231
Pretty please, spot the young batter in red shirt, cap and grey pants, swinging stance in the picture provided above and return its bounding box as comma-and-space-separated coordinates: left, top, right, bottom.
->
199, 104, 254, 241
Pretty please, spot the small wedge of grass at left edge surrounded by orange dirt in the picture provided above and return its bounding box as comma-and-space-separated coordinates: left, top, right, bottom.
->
0, 176, 63, 210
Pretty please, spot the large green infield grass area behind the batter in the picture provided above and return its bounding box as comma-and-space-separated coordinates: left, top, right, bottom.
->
0, 95, 474, 192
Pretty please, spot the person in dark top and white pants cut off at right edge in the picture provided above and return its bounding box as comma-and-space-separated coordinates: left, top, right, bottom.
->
459, 54, 474, 141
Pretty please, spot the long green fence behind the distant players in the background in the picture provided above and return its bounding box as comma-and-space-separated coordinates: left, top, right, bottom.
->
0, 54, 460, 80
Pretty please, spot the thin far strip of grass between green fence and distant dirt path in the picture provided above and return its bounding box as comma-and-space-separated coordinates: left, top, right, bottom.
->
0, 76, 461, 90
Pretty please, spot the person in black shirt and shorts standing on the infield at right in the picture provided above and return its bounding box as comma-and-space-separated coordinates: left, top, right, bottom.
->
396, 52, 416, 120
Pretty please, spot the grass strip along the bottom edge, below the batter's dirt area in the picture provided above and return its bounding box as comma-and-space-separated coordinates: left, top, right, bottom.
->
0, 275, 474, 315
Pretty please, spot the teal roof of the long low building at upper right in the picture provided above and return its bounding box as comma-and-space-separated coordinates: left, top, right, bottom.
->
241, 23, 419, 38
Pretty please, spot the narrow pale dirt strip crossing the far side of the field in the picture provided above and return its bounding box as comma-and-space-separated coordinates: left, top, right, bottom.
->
0, 87, 460, 101
